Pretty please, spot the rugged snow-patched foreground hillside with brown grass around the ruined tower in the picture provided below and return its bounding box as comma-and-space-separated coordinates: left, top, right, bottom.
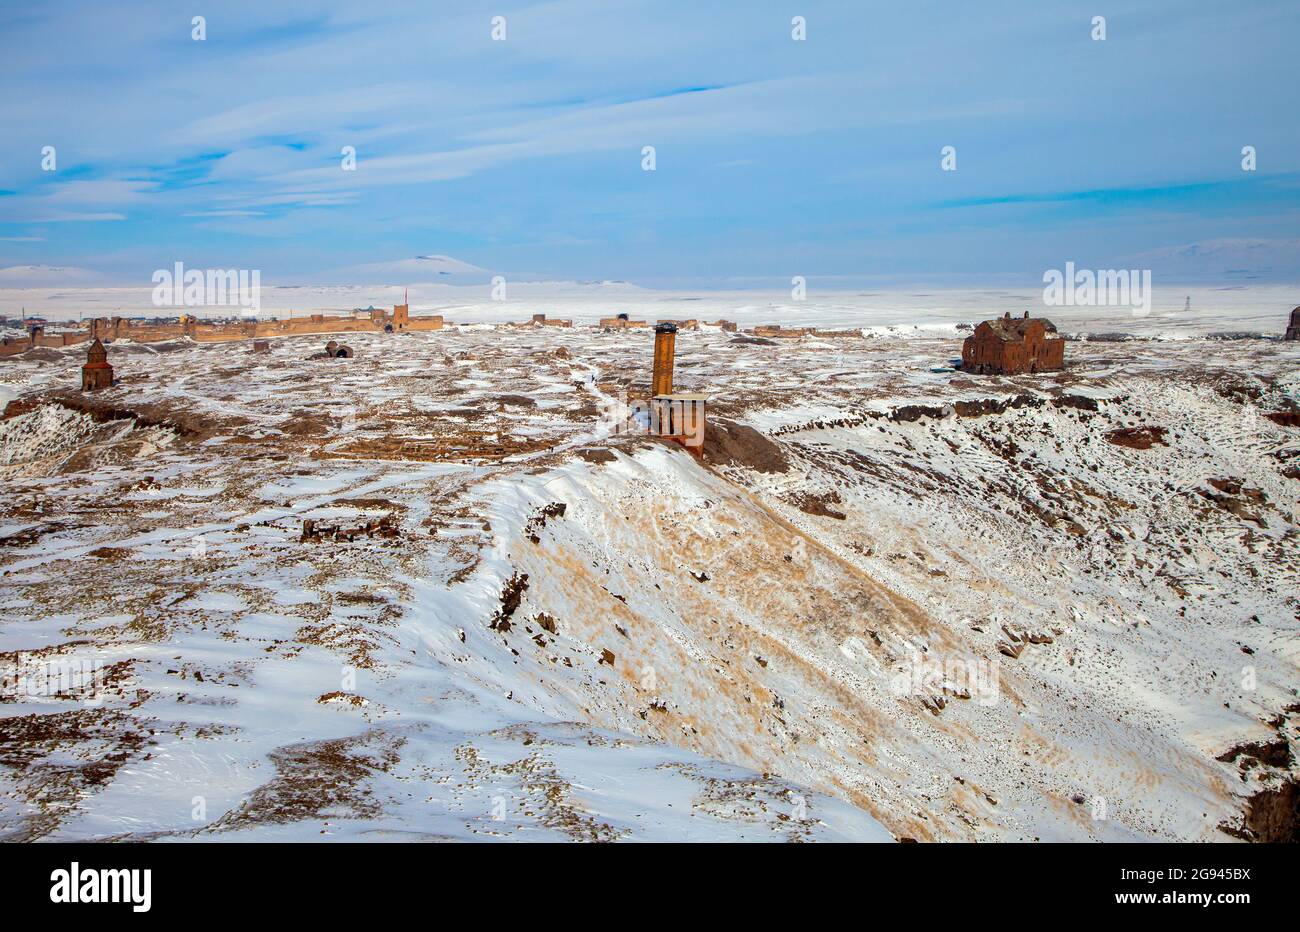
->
0, 298, 1300, 841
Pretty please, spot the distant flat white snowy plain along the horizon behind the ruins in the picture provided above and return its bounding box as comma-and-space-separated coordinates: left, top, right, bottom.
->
0, 277, 1296, 339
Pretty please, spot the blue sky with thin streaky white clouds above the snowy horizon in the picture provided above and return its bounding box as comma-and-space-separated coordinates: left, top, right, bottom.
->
0, 0, 1300, 287
